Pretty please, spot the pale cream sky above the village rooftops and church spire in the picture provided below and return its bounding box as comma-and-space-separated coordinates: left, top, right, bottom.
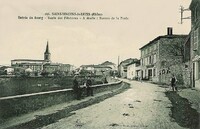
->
0, 0, 191, 66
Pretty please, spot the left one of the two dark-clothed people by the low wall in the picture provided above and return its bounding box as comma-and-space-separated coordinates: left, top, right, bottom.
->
73, 76, 81, 100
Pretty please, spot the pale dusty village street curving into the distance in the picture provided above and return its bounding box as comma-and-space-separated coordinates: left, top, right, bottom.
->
43, 81, 191, 129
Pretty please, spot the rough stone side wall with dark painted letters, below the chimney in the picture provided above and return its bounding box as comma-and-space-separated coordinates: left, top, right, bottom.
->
157, 36, 187, 85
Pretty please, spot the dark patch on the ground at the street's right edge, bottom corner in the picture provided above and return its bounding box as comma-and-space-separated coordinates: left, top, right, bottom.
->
165, 91, 200, 129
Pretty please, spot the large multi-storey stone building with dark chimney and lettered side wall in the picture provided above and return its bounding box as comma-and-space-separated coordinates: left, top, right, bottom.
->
140, 27, 187, 83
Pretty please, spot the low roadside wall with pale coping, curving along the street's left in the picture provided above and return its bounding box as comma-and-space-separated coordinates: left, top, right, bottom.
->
0, 81, 122, 123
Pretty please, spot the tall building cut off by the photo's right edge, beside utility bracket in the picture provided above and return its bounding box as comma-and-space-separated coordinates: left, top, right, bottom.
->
190, 0, 200, 89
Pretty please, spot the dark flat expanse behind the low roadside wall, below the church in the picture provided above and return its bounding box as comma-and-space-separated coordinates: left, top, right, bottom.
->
0, 76, 104, 97
